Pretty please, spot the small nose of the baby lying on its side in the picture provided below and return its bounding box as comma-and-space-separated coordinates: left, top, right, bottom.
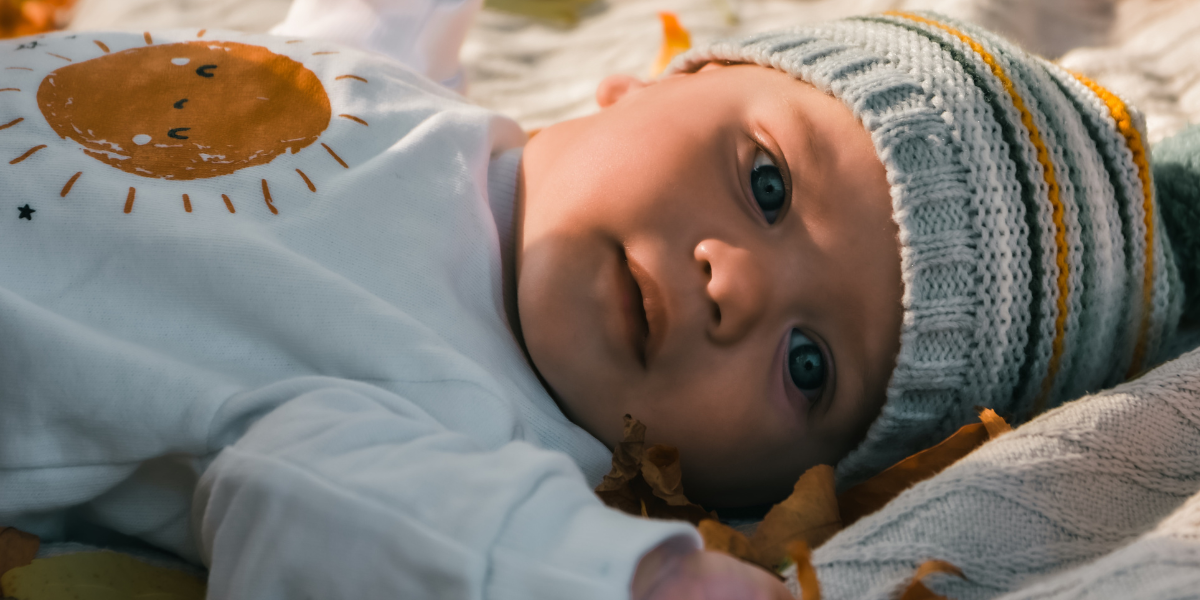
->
692, 239, 767, 344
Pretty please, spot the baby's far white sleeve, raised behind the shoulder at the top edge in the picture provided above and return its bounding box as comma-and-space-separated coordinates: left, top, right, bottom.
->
271, 0, 482, 92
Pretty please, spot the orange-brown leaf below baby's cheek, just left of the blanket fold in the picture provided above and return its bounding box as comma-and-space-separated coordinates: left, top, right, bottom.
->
750, 464, 841, 569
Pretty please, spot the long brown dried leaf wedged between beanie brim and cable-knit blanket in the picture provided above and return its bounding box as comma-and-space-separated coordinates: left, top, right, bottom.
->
838, 408, 1013, 527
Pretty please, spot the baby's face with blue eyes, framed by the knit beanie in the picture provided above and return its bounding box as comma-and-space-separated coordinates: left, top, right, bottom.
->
516, 65, 902, 506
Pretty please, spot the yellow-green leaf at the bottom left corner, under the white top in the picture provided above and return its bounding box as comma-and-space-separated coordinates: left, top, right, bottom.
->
0, 551, 205, 600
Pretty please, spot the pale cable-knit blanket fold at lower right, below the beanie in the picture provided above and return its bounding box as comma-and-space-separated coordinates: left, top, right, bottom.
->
793, 350, 1200, 600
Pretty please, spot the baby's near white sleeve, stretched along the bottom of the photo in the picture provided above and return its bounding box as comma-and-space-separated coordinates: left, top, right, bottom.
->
192, 386, 698, 600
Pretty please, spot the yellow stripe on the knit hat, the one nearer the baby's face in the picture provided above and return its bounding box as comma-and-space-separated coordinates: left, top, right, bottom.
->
884, 11, 1070, 414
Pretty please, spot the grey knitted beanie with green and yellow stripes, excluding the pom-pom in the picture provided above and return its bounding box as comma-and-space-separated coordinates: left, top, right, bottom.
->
668, 12, 1183, 488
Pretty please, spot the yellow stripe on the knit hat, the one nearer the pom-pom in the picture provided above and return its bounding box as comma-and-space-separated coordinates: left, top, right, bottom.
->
1070, 72, 1154, 378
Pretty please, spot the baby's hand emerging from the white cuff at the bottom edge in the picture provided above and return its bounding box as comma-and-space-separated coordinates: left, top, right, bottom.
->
632, 547, 794, 600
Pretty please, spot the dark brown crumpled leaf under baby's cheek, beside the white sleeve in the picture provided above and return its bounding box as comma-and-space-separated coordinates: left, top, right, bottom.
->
595, 415, 716, 524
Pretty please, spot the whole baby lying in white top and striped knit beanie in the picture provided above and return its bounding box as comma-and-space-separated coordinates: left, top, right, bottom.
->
0, 1, 1182, 599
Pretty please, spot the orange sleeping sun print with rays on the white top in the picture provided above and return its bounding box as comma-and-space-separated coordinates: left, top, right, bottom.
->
0, 30, 367, 215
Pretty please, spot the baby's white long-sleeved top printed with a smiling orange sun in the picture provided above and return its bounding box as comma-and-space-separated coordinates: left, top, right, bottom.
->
0, 0, 698, 600
